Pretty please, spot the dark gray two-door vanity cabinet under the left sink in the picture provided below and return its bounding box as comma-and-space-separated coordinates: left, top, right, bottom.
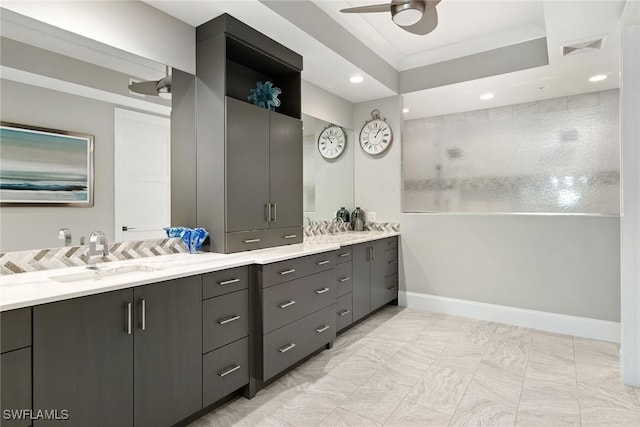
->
33, 276, 202, 427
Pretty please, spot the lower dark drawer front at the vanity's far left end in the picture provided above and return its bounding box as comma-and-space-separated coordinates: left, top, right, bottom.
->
0, 347, 31, 427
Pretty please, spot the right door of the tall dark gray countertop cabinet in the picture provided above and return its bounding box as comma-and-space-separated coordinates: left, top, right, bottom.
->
269, 113, 302, 228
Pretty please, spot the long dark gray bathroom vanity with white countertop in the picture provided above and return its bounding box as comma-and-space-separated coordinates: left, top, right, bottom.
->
0, 231, 398, 427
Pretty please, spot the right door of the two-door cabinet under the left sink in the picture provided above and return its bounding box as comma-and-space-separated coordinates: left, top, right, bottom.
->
134, 276, 202, 427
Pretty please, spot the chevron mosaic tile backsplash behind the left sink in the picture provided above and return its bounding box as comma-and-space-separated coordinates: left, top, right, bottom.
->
0, 237, 189, 274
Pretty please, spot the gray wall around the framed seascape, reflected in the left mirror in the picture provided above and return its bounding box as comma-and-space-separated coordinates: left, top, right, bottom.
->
0, 80, 114, 252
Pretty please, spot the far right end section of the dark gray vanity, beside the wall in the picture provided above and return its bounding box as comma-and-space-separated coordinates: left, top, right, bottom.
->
352, 237, 398, 321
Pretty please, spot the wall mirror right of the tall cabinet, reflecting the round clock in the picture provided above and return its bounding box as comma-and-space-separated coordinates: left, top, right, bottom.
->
302, 114, 354, 224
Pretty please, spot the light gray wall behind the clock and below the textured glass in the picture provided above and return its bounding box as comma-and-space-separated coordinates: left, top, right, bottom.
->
354, 97, 620, 321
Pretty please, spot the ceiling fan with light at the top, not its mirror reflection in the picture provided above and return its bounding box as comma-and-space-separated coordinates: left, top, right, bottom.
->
340, 0, 440, 36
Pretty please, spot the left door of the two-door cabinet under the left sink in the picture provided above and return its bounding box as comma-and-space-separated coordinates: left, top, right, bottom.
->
33, 289, 133, 427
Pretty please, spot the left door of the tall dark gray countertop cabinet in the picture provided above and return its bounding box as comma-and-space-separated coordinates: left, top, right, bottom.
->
226, 98, 272, 232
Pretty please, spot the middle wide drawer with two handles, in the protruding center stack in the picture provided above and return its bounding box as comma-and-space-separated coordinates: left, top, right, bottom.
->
262, 270, 336, 334
